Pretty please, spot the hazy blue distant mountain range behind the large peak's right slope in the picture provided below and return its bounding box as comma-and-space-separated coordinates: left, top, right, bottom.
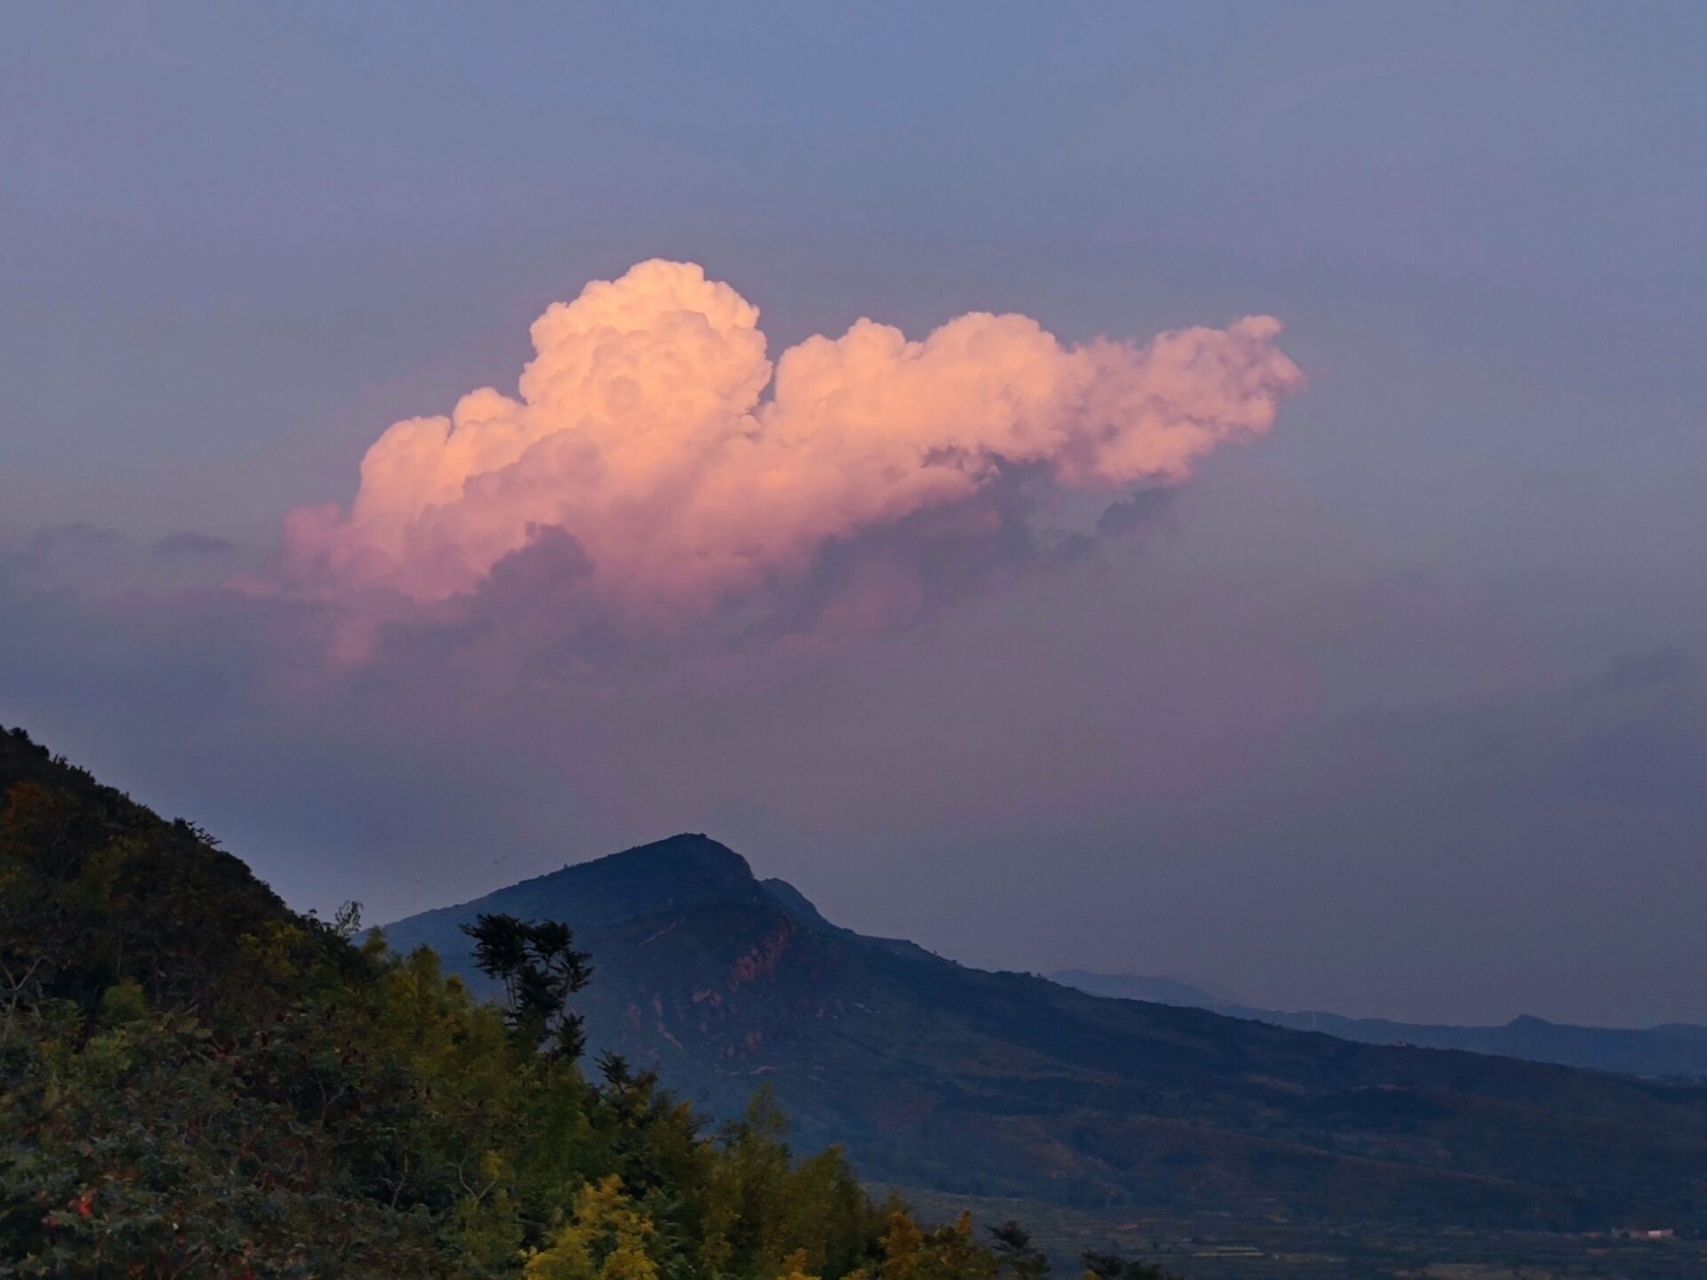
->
1050, 969, 1707, 1080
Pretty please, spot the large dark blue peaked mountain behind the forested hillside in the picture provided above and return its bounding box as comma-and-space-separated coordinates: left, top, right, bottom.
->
386, 835, 1707, 1229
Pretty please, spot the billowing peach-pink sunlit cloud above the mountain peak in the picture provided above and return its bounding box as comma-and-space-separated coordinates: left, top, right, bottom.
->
287, 261, 1302, 631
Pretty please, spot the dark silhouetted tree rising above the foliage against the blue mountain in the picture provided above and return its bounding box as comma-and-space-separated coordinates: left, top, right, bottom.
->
463, 915, 592, 1062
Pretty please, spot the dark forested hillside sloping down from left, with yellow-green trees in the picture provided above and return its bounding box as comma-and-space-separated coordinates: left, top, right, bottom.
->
0, 730, 1119, 1280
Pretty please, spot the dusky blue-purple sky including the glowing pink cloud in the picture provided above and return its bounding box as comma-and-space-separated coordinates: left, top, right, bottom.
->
0, 3, 1707, 1024
